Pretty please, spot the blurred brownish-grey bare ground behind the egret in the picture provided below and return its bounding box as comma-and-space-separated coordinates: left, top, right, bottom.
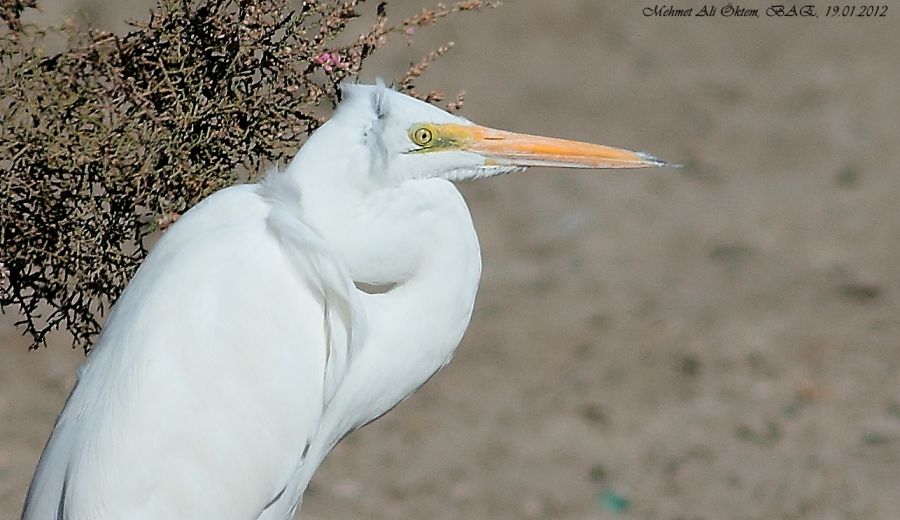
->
0, 0, 900, 520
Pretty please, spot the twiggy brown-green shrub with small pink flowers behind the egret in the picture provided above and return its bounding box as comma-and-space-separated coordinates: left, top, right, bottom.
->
0, 0, 492, 352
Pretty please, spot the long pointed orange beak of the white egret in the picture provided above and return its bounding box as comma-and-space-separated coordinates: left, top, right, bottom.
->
440, 124, 667, 168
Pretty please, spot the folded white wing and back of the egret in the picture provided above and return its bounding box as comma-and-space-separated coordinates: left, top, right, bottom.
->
23, 185, 356, 520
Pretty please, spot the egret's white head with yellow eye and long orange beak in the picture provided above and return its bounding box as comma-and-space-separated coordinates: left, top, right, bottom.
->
333, 84, 666, 183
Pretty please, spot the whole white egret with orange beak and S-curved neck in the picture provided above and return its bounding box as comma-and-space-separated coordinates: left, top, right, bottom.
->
23, 85, 664, 520
